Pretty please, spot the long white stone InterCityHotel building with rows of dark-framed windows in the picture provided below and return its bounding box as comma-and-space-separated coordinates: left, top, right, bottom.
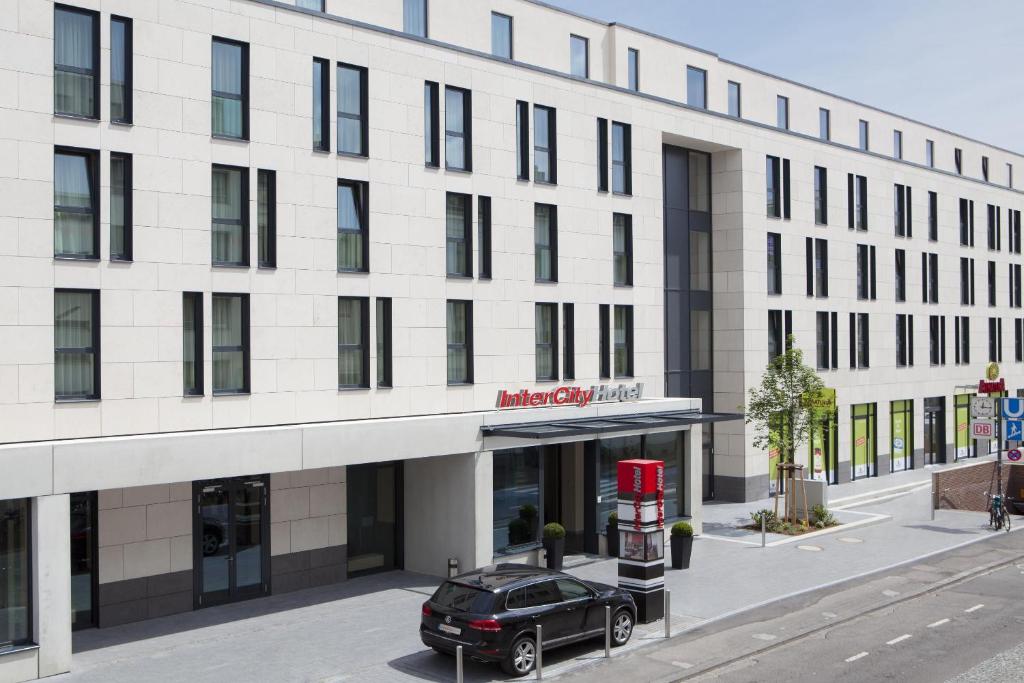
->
0, 0, 1024, 681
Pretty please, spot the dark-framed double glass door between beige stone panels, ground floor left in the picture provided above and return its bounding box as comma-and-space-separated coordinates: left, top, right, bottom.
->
194, 476, 270, 607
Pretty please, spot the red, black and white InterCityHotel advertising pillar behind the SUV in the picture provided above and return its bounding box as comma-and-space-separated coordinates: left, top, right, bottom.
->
618, 460, 665, 624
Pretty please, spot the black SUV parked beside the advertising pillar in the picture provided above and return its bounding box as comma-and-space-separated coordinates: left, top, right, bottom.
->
420, 564, 637, 676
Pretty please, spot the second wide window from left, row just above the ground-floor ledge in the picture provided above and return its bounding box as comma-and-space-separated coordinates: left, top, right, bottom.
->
213, 294, 249, 395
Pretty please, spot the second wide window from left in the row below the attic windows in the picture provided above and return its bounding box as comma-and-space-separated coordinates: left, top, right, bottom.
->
211, 38, 249, 140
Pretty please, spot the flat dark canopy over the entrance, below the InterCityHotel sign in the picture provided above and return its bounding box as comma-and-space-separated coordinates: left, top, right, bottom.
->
480, 411, 743, 439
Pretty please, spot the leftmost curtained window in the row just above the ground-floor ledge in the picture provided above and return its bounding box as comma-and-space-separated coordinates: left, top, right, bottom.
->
53, 290, 99, 400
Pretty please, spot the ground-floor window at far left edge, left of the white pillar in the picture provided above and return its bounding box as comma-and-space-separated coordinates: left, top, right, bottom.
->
0, 498, 34, 656
